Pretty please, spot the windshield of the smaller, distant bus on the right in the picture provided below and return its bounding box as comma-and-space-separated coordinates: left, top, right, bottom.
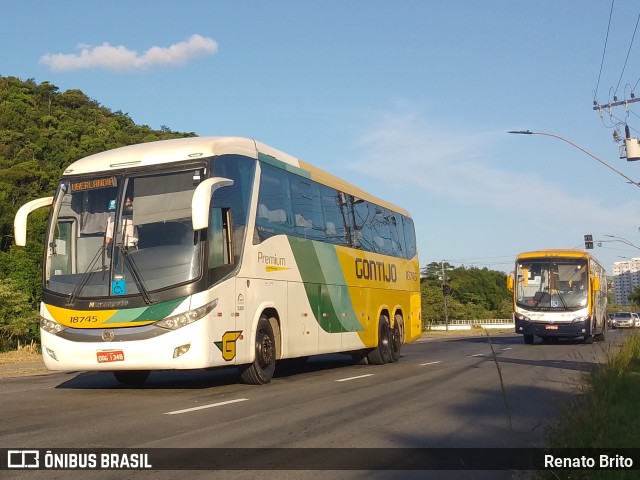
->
516, 258, 588, 310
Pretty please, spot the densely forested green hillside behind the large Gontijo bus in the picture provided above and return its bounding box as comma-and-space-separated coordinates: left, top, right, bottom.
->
0, 76, 194, 351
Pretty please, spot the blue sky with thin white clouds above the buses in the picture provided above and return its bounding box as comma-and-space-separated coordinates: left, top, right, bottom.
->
0, 0, 640, 274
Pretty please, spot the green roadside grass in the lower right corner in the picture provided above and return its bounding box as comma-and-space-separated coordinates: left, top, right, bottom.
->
538, 333, 640, 480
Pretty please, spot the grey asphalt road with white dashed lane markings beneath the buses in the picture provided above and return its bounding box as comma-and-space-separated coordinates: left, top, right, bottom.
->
0, 331, 625, 479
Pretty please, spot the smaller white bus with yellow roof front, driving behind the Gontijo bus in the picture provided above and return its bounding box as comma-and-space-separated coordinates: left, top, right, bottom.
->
507, 249, 607, 344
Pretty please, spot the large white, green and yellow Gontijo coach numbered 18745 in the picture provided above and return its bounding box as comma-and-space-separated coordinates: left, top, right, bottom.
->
14, 137, 421, 384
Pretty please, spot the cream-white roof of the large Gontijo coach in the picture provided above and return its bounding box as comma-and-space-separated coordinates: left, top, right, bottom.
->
64, 137, 411, 217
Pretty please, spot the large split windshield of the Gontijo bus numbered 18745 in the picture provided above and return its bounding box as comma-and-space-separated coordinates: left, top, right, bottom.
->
44, 168, 202, 299
